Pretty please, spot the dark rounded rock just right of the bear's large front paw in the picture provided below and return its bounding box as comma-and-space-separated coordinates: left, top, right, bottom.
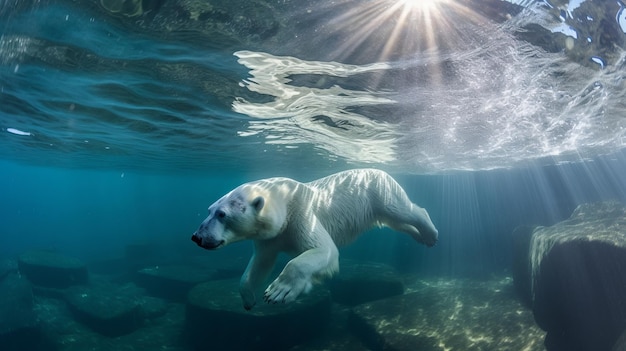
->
330, 260, 404, 306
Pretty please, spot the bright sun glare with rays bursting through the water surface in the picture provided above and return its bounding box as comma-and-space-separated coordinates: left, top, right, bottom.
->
316, 0, 478, 70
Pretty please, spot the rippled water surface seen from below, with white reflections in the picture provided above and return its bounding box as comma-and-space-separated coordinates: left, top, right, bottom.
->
0, 0, 626, 173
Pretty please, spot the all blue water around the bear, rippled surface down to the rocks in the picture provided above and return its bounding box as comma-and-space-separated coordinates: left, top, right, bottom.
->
0, 0, 626, 350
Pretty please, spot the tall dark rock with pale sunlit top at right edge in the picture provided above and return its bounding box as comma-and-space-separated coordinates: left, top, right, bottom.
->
529, 202, 626, 351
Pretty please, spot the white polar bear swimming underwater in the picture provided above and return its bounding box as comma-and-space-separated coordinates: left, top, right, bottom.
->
191, 169, 438, 310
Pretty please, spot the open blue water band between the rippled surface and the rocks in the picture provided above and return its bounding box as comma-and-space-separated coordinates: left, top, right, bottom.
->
0, 153, 626, 276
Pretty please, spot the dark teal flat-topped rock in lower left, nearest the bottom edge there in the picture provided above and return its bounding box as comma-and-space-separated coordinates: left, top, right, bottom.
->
65, 283, 145, 336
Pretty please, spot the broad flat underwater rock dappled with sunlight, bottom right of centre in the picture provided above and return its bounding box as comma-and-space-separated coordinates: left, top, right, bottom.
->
350, 278, 544, 351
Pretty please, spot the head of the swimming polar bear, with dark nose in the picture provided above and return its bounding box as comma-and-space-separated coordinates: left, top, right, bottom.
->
191, 182, 287, 250
